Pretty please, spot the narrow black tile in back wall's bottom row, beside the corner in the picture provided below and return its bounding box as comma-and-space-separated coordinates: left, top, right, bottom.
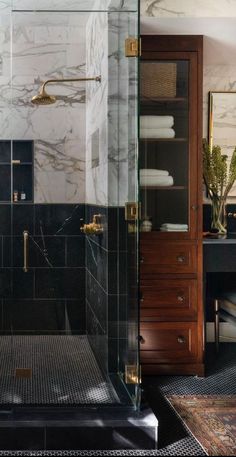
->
65, 297, 86, 335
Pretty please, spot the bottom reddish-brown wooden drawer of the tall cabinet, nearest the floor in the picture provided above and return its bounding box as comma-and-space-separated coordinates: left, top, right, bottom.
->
140, 322, 198, 364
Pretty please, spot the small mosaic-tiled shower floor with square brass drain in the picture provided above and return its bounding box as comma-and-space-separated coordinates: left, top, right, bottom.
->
0, 335, 119, 405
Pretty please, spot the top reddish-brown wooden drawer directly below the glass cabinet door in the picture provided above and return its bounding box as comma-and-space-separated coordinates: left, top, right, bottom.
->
140, 239, 197, 277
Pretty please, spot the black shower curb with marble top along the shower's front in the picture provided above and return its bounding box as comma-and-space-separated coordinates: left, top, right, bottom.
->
0, 407, 158, 451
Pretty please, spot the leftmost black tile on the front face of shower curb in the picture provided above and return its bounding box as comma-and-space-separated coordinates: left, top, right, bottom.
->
0, 427, 44, 451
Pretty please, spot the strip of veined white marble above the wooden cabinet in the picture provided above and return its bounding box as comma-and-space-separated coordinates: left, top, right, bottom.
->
141, 0, 236, 18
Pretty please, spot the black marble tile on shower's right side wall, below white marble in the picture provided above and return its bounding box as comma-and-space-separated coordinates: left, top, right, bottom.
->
85, 205, 128, 373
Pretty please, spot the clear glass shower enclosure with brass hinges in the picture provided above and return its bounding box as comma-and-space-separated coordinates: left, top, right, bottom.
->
0, 0, 140, 410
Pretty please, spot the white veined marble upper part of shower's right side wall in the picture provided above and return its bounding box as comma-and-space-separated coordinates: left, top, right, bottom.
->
86, 6, 137, 206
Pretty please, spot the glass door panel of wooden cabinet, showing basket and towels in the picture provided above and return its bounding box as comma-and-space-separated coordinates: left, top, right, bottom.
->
140, 61, 189, 232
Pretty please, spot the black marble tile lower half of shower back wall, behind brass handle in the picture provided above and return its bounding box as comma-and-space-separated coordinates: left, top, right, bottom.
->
0, 203, 86, 334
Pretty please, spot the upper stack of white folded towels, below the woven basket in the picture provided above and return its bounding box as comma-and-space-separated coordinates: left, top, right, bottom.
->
140, 116, 175, 138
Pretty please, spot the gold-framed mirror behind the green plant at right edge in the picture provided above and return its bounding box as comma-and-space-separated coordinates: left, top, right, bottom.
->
208, 91, 236, 197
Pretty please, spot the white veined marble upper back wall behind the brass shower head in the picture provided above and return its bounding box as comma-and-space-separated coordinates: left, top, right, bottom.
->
0, 8, 88, 203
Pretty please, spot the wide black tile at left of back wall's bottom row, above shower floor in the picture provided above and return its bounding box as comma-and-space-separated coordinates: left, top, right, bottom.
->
3, 298, 65, 333
